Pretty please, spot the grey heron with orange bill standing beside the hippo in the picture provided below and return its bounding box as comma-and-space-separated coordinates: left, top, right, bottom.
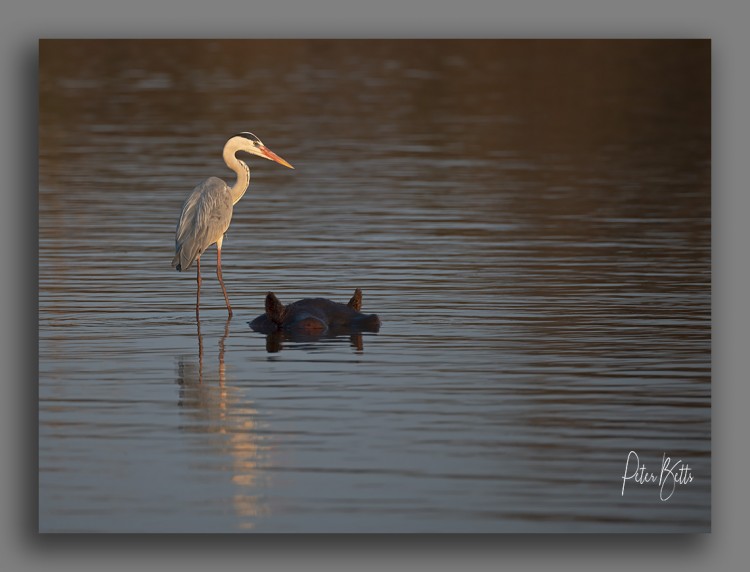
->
172, 132, 294, 317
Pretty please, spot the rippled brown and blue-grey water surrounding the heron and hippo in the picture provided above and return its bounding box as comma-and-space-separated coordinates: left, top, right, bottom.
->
39, 41, 711, 532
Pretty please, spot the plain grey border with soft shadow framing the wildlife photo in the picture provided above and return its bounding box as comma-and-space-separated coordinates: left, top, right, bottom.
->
7, 0, 750, 571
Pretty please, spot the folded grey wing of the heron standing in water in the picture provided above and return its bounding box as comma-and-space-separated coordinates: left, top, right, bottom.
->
172, 177, 232, 270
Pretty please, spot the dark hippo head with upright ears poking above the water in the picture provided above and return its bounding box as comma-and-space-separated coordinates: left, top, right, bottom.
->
250, 288, 380, 336
